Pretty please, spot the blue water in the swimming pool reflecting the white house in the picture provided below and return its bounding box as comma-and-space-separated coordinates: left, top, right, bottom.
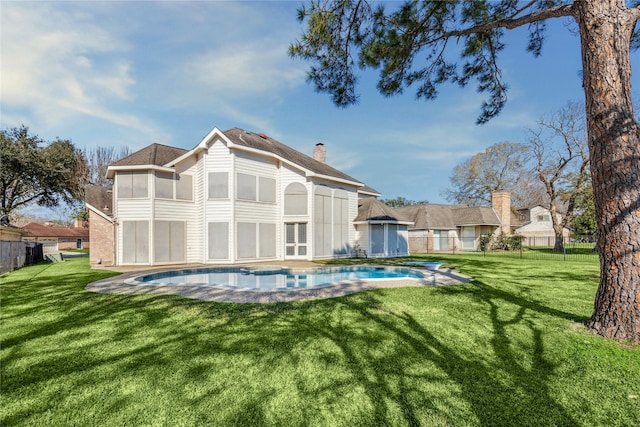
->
128, 266, 425, 289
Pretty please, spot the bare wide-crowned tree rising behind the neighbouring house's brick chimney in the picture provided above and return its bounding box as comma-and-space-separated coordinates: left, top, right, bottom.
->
444, 142, 527, 206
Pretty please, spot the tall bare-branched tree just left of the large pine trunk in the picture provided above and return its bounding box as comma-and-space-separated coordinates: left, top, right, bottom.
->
529, 103, 591, 252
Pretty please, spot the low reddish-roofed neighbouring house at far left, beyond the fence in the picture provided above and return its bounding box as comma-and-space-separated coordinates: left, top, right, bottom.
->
21, 222, 89, 254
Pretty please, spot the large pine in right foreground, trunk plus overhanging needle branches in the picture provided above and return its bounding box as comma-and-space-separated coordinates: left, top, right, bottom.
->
290, 0, 640, 342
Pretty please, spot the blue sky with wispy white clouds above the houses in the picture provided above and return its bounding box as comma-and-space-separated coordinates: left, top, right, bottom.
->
0, 1, 640, 207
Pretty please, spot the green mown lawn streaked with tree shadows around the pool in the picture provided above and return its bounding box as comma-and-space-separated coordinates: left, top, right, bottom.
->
0, 255, 640, 426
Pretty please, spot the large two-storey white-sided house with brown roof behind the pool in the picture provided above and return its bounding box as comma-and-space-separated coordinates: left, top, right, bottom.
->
86, 128, 409, 265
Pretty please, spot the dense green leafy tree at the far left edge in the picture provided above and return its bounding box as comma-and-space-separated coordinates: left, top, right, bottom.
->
0, 126, 85, 221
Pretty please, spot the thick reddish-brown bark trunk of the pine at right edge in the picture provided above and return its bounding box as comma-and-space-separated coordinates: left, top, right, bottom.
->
575, 0, 640, 343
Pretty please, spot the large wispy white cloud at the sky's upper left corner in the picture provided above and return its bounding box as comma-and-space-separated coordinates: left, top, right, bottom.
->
1, 2, 158, 132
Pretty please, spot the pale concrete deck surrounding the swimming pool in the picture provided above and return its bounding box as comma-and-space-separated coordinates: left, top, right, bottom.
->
85, 262, 472, 303
